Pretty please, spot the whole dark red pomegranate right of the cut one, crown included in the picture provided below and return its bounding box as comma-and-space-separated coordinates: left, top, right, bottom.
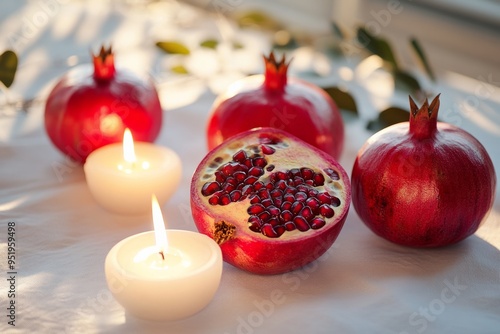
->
352, 95, 496, 247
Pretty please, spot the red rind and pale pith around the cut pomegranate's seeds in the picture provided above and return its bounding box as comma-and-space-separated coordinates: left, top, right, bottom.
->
191, 128, 351, 275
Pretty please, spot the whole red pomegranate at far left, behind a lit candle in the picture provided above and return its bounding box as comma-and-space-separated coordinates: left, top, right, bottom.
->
45, 47, 162, 163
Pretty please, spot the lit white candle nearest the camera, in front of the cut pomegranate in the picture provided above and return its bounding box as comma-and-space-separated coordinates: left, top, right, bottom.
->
105, 198, 222, 321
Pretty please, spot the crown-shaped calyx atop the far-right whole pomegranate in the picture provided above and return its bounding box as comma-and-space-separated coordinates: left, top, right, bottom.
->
409, 94, 441, 139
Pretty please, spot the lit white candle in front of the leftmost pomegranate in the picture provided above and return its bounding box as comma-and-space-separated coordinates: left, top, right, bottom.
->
84, 129, 182, 214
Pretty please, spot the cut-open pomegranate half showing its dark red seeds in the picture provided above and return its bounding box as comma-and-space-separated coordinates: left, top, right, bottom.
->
191, 128, 351, 274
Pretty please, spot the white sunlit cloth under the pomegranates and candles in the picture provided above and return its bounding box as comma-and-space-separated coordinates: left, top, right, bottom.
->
0, 0, 500, 334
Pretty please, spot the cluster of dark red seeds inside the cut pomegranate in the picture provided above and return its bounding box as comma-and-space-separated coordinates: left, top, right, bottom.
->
201, 144, 340, 238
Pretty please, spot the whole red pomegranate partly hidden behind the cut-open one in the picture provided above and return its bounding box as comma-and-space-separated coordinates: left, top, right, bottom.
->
207, 53, 344, 159
